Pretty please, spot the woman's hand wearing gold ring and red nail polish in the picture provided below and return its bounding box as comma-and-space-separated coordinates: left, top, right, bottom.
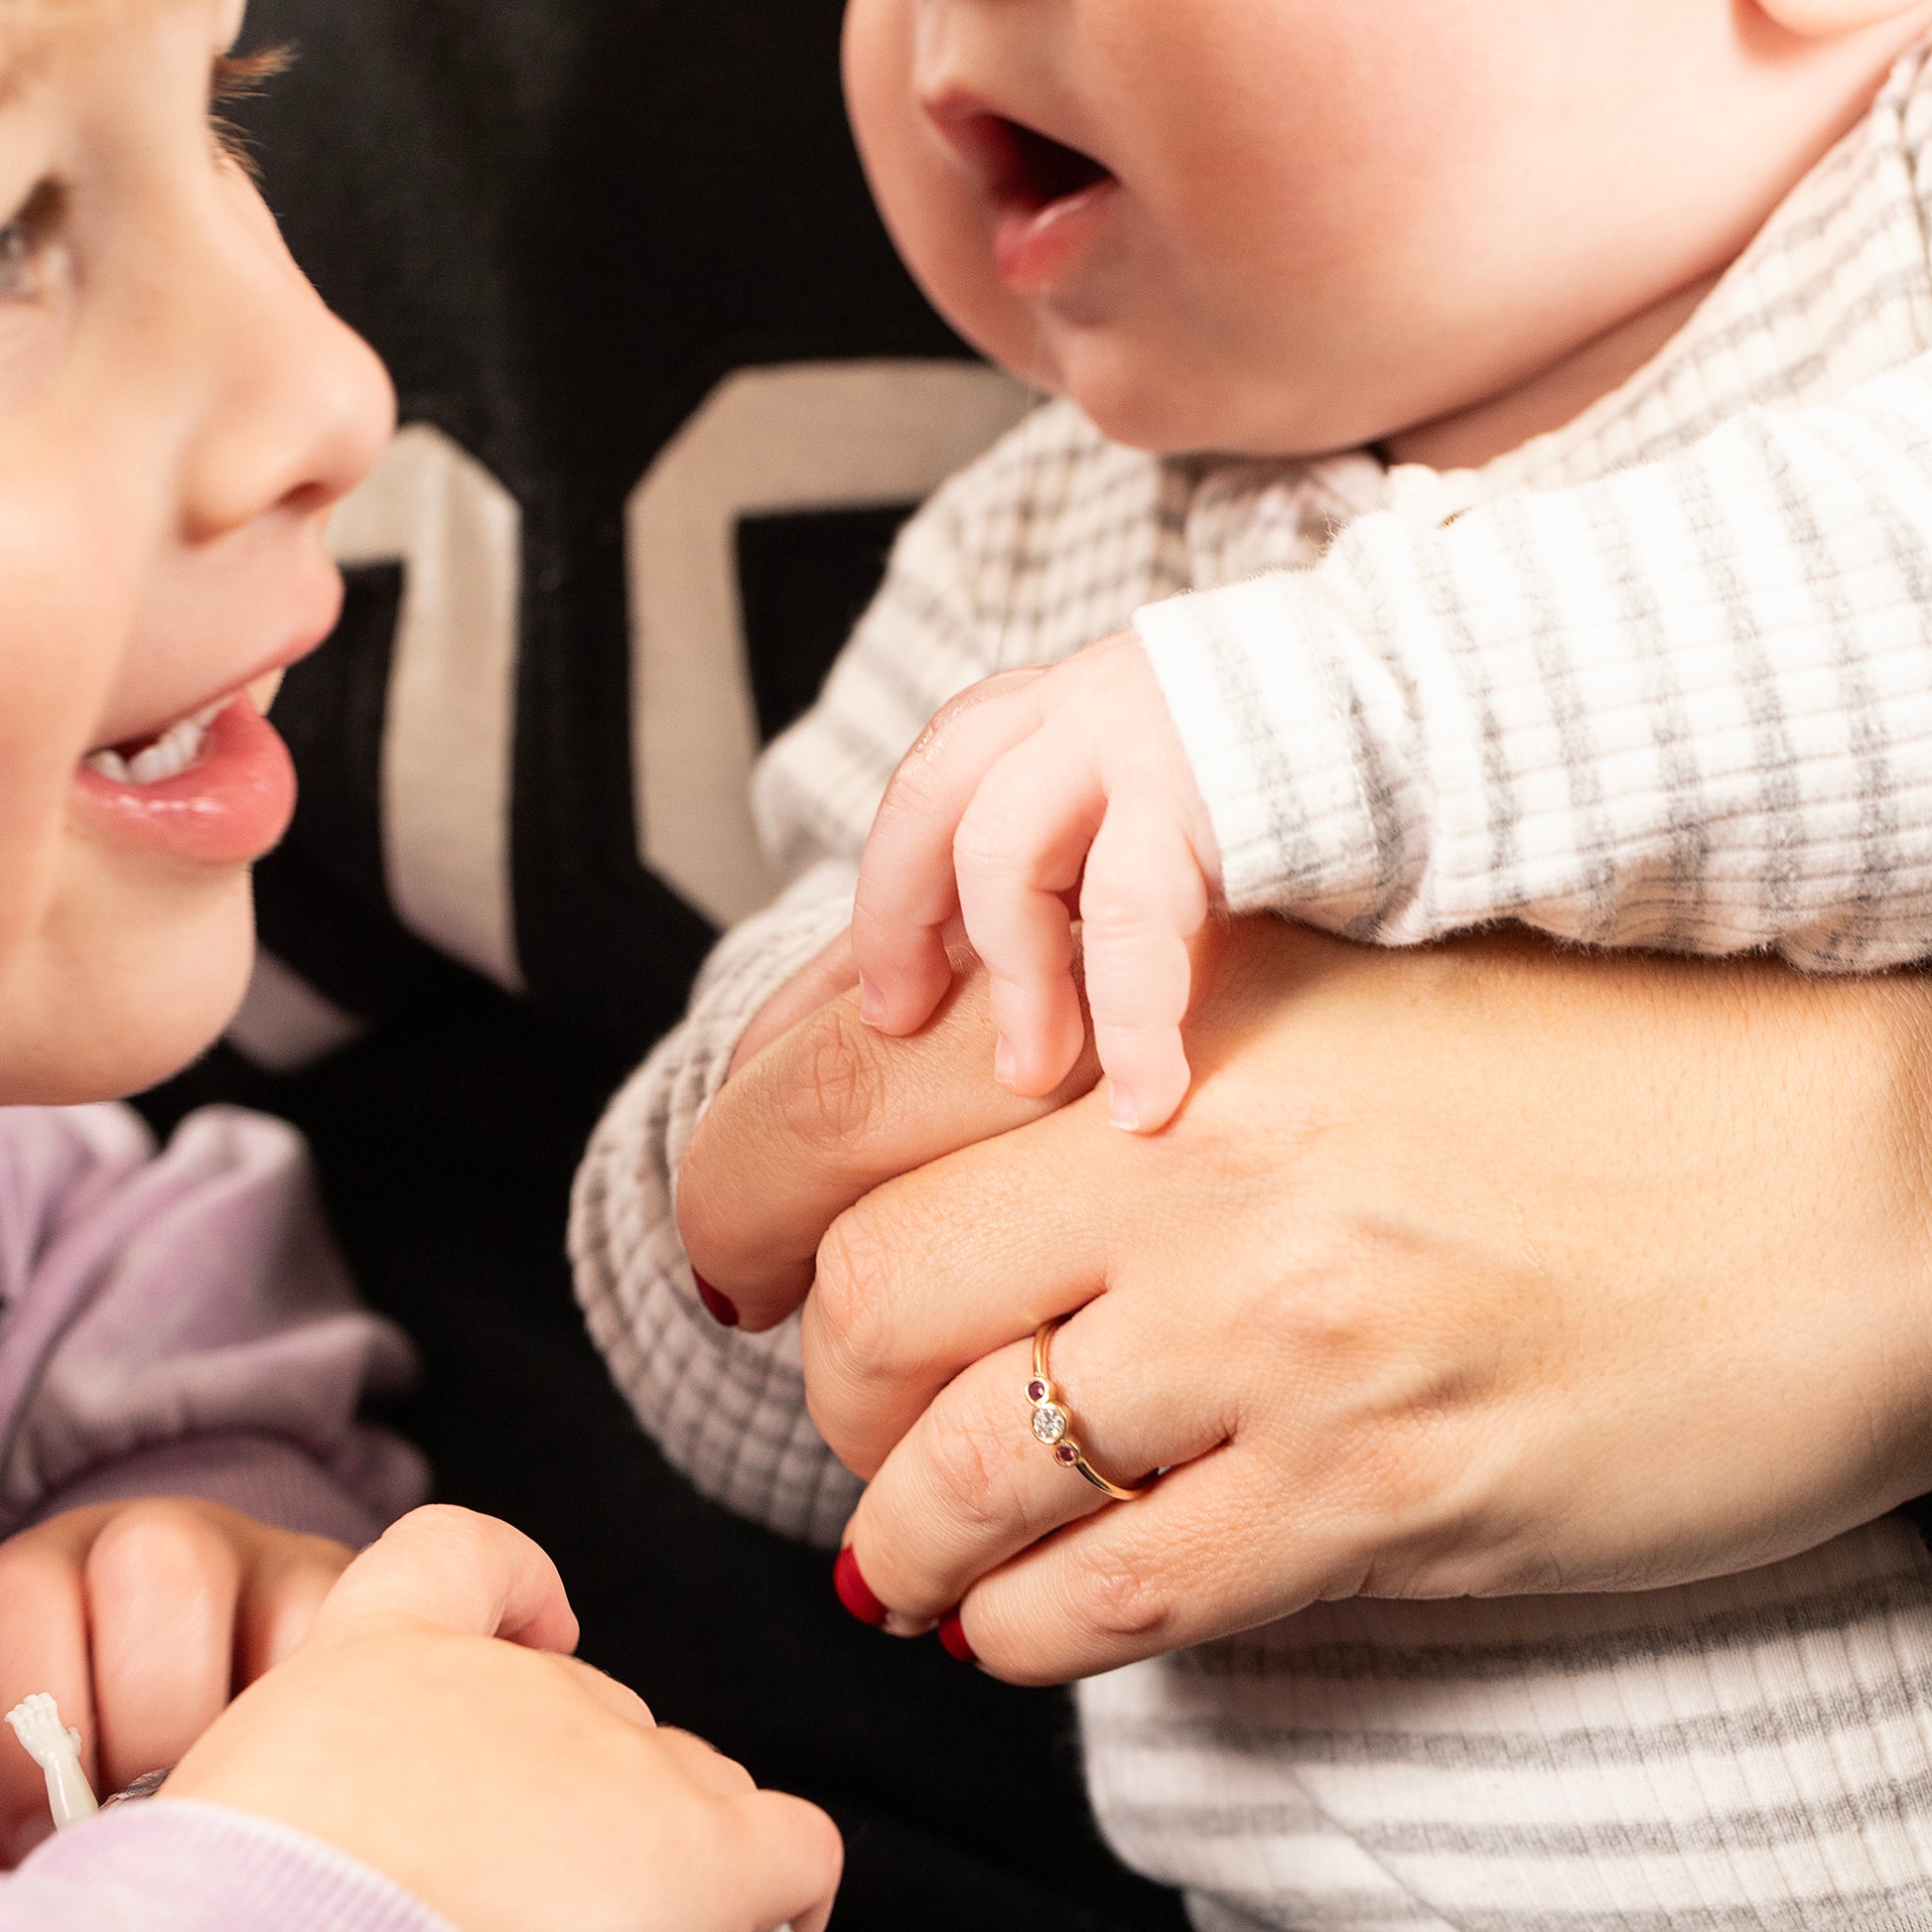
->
678, 921, 1932, 1681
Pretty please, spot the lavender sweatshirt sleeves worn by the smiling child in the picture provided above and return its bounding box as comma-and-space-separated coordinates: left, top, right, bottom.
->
0, 1105, 450, 1932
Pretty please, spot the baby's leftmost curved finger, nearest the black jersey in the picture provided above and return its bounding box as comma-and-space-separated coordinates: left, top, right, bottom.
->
852, 670, 1043, 1034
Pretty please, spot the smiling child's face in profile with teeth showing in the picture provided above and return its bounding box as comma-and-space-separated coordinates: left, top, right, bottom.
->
0, 0, 392, 1101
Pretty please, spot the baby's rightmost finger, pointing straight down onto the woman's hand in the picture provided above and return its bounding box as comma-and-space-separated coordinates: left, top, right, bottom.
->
1080, 798, 1207, 1134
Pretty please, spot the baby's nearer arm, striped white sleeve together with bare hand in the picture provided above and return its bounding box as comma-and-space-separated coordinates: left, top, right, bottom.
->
854, 359, 1932, 1128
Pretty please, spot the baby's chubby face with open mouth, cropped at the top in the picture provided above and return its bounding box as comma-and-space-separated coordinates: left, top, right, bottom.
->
846, 0, 1924, 456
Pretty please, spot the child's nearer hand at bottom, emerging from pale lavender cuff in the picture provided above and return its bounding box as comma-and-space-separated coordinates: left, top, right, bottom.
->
172, 1509, 841, 1932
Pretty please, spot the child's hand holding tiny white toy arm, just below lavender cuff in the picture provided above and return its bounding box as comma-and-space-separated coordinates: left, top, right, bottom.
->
0, 1497, 349, 1864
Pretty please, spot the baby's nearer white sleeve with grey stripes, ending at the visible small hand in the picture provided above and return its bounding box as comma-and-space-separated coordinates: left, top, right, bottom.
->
1134, 359, 1932, 972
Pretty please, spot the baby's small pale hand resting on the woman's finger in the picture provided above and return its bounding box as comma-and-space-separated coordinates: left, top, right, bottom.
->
852, 631, 1221, 1132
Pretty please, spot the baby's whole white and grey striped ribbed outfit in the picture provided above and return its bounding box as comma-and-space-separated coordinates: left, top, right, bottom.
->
572, 34, 1932, 1932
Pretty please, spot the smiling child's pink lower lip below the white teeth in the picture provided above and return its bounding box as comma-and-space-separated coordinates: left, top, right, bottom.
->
73, 692, 296, 866
